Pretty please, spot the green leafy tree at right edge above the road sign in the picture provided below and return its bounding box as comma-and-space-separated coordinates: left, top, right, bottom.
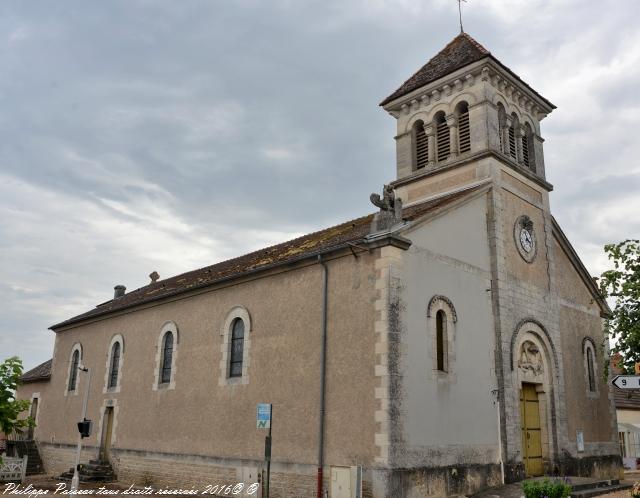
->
600, 239, 640, 373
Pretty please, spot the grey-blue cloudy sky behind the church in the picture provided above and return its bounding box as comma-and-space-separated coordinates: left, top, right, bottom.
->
0, 0, 640, 368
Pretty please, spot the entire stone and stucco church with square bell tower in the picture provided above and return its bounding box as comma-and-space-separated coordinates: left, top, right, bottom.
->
19, 33, 621, 498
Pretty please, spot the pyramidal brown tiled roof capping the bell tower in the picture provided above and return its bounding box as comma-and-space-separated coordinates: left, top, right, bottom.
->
380, 33, 555, 109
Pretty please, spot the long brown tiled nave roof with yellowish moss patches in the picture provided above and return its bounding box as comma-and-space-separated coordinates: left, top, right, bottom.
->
50, 189, 480, 330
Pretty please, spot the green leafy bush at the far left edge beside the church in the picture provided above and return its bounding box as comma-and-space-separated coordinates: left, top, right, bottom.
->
0, 356, 33, 434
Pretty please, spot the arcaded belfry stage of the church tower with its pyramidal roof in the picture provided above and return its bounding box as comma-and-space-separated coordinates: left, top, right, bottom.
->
380, 32, 555, 205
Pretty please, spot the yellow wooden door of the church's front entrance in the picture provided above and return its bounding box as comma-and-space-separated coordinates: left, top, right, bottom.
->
520, 383, 543, 477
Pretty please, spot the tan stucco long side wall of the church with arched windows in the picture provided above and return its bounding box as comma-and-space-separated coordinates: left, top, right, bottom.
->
20, 254, 375, 472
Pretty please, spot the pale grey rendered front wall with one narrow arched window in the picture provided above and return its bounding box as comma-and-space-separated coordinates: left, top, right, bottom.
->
398, 195, 498, 466
